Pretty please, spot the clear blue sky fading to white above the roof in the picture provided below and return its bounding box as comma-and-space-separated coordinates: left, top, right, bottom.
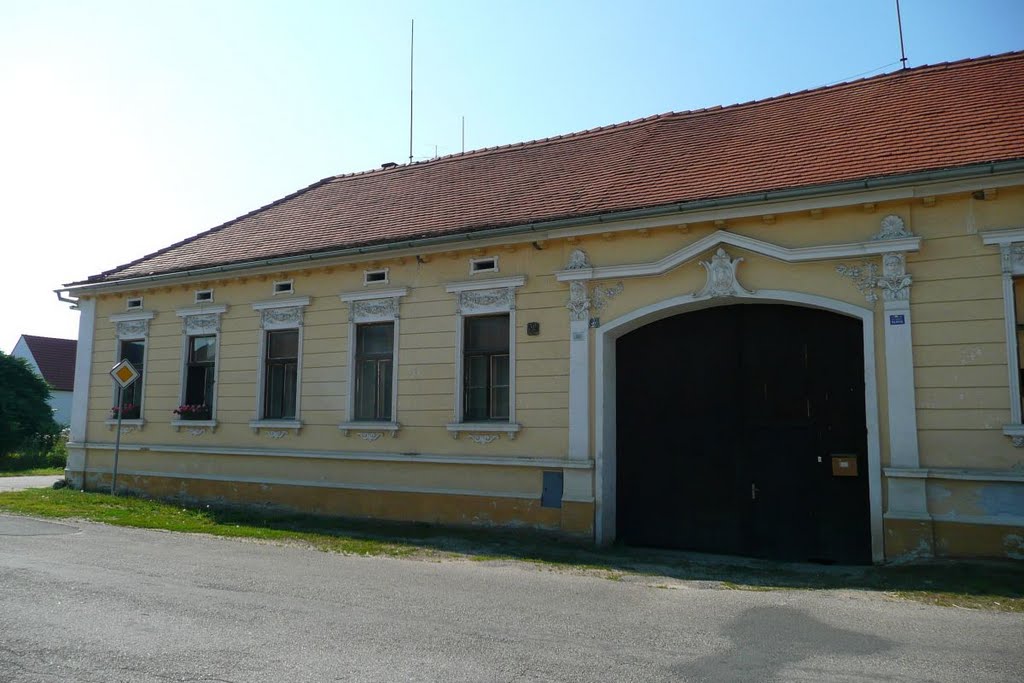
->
0, 0, 1024, 351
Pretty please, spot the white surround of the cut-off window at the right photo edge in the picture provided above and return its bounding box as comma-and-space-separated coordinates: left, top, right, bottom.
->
978, 227, 1024, 449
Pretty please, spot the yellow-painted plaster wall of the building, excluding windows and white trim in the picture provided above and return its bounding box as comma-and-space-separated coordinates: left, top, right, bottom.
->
75, 183, 1024, 554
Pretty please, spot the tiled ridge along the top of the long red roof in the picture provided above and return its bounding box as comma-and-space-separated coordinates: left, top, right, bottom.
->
324, 50, 1024, 182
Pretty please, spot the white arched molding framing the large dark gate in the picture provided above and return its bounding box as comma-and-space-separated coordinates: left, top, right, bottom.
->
594, 290, 885, 562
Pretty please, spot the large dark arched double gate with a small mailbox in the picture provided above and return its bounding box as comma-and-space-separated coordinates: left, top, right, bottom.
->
615, 304, 871, 563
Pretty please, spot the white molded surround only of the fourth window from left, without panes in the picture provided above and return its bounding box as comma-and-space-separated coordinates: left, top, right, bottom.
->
338, 287, 409, 441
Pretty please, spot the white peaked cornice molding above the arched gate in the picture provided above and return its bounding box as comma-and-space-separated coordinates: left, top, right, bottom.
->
555, 230, 921, 282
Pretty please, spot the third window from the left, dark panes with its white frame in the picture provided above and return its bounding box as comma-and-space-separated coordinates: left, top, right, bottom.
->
249, 297, 309, 435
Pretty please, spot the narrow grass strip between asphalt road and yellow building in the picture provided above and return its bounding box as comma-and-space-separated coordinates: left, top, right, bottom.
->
0, 488, 1024, 612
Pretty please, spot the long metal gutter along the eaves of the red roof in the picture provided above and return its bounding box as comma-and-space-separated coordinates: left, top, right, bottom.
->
61, 159, 1024, 294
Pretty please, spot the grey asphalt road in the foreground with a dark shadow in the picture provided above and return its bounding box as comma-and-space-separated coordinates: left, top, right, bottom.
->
0, 515, 1024, 683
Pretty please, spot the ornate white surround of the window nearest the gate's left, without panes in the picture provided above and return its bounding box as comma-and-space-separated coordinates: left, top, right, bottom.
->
444, 275, 526, 442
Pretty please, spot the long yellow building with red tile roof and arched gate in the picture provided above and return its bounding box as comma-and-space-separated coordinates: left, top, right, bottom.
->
61, 52, 1024, 562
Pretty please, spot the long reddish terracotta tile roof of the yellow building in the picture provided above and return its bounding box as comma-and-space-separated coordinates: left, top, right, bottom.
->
88, 52, 1024, 282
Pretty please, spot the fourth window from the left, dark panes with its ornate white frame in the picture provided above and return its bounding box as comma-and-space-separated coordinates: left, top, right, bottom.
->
339, 288, 409, 435
